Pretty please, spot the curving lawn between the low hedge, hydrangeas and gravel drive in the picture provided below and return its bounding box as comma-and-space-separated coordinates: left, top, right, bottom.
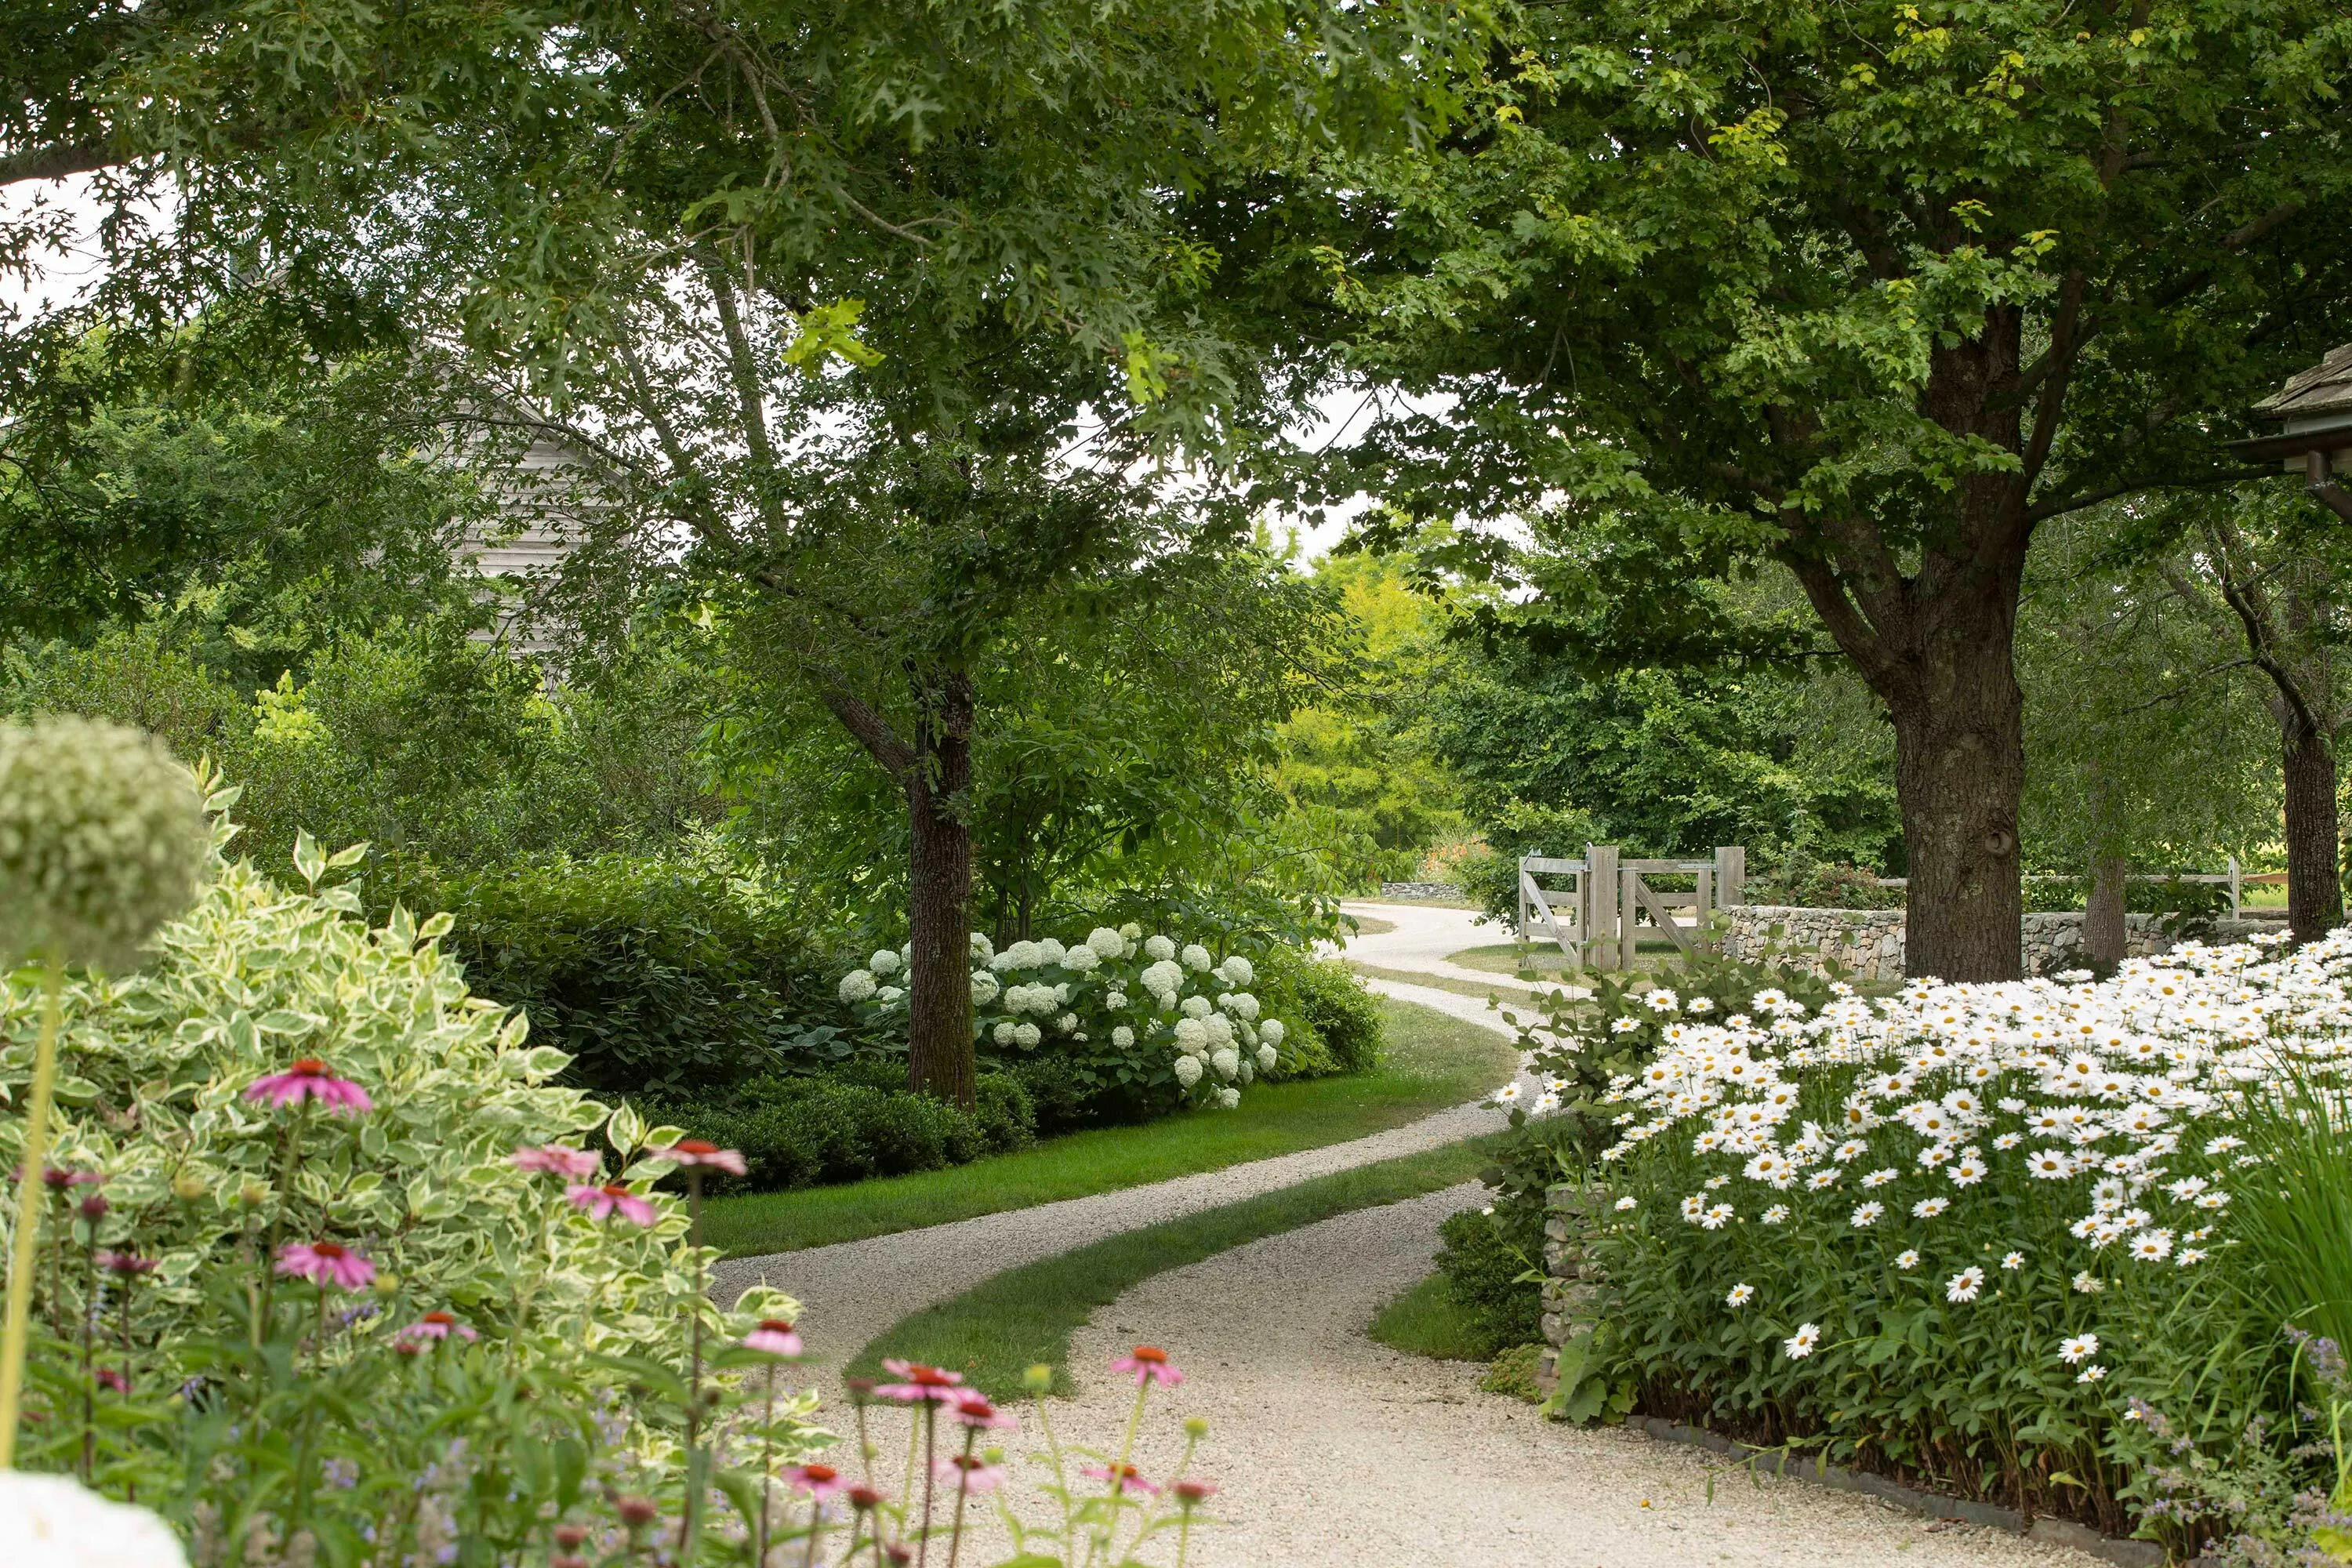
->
703, 999, 1517, 1258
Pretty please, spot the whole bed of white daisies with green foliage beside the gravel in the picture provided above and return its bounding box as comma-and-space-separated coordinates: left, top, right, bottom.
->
1543, 933, 2352, 1549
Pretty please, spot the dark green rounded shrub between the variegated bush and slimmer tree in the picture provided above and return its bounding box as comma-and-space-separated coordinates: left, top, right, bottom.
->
390, 855, 851, 1091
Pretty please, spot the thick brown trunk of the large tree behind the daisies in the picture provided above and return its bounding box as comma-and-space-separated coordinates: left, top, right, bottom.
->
1884, 616, 2025, 980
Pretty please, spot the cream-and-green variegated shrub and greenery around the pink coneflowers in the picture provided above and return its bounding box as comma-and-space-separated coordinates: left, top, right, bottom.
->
0, 797, 809, 1561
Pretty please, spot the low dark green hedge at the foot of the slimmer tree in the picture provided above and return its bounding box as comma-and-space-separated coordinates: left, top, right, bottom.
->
637, 1067, 1035, 1192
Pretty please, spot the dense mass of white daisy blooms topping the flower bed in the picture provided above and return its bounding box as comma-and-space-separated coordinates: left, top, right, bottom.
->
1602, 931, 2352, 1382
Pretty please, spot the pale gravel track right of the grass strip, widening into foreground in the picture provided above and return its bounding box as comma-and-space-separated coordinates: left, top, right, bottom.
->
1030, 1182, 2086, 1568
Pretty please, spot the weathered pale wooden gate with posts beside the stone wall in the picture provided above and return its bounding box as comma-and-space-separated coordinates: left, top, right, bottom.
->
1519, 844, 1748, 968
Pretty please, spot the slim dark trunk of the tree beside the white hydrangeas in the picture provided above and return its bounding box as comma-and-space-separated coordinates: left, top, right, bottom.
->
903, 670, 976, 1109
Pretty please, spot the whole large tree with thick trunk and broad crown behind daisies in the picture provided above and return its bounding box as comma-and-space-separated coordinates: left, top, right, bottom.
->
1298, 0, 2352, 980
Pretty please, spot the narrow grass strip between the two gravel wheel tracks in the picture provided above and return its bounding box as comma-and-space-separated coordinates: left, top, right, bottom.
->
849, 1138, 1496, 1399
